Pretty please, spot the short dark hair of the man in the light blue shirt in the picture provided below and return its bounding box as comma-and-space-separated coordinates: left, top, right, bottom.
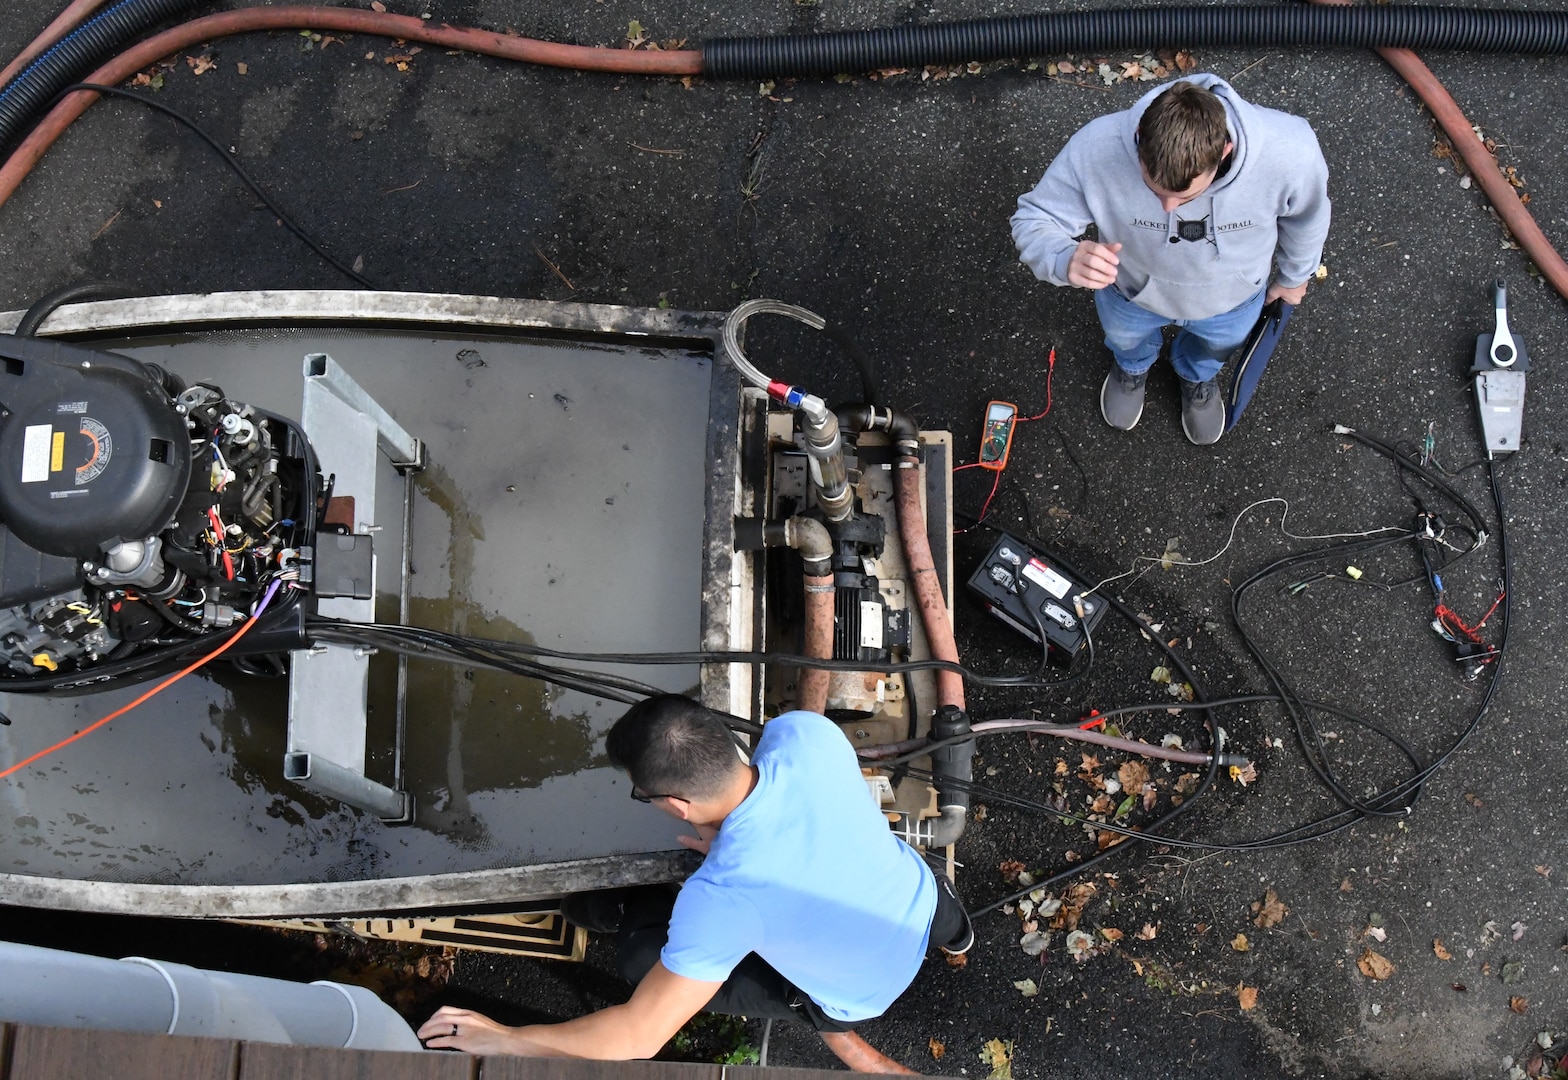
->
605, 694, 743, 799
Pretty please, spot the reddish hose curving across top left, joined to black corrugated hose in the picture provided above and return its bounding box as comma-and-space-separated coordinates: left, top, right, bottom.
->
0, 6, 702, 205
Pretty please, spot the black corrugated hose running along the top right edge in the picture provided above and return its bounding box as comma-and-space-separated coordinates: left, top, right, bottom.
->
702, 6, 1568, 78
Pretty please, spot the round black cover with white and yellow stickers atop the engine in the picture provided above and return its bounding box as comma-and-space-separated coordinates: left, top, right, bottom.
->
0, 335, 191, 560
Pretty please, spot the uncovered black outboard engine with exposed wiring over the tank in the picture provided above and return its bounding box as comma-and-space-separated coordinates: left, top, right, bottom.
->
0, 335, 321, 690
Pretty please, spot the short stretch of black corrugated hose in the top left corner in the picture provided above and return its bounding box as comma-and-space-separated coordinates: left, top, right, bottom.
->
0, 0, 201, 149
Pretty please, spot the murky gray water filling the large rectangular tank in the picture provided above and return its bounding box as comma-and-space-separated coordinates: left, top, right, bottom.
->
0, 329, 710, 884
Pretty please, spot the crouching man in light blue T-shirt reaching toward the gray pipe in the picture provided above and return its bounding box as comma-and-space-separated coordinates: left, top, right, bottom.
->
419, 694, 974, 1072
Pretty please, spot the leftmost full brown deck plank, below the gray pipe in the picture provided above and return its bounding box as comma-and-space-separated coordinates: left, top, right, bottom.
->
6, 1025, 238, 1080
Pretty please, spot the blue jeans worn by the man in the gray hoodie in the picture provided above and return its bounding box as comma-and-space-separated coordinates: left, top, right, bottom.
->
1094, 285, 1265, 382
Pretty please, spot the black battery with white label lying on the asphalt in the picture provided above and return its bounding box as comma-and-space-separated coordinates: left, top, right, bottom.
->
969, 533, 1105, 661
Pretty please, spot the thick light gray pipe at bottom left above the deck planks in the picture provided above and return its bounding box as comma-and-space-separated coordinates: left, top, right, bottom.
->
0, 942, 422, 1050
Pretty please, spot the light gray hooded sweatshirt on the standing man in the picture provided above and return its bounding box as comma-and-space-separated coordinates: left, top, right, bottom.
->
1013, 75, 1328, 320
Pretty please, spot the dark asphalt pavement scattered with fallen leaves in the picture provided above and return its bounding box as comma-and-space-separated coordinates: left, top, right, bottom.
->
0, 0, 1568, 1080
